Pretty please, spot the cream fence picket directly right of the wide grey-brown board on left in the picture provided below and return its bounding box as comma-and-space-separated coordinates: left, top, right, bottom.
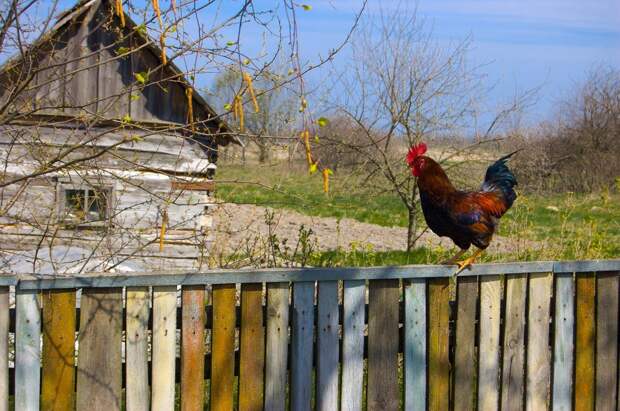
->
125, 287, 151, 411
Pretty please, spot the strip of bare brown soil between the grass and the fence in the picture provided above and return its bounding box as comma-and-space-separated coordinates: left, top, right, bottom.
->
214, 204, 532, 253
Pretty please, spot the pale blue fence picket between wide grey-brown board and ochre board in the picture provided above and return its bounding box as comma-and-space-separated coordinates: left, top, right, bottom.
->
404, 280, 426, 411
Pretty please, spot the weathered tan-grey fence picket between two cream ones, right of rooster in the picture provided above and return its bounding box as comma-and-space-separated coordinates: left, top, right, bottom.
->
501, 274, 527, 411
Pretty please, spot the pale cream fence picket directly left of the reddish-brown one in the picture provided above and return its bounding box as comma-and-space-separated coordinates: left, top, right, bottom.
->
151, 286, 177, 411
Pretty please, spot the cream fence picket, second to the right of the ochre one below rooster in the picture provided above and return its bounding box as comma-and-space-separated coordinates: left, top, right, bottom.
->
478, 276, 502, 411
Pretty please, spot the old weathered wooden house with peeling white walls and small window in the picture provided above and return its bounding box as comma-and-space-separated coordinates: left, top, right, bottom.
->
0, 0, 238, 273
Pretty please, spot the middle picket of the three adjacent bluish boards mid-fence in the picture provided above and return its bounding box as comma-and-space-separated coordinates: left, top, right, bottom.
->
316, 281, 340, 411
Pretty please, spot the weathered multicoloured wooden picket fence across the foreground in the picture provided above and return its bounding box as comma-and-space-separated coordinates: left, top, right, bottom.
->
0, 260, 620, 411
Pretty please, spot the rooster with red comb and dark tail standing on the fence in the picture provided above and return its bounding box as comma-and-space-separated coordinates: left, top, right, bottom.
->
407, 143, 518, 275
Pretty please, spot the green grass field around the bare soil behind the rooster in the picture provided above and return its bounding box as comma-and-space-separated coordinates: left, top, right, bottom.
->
216, 165, 620, 265
